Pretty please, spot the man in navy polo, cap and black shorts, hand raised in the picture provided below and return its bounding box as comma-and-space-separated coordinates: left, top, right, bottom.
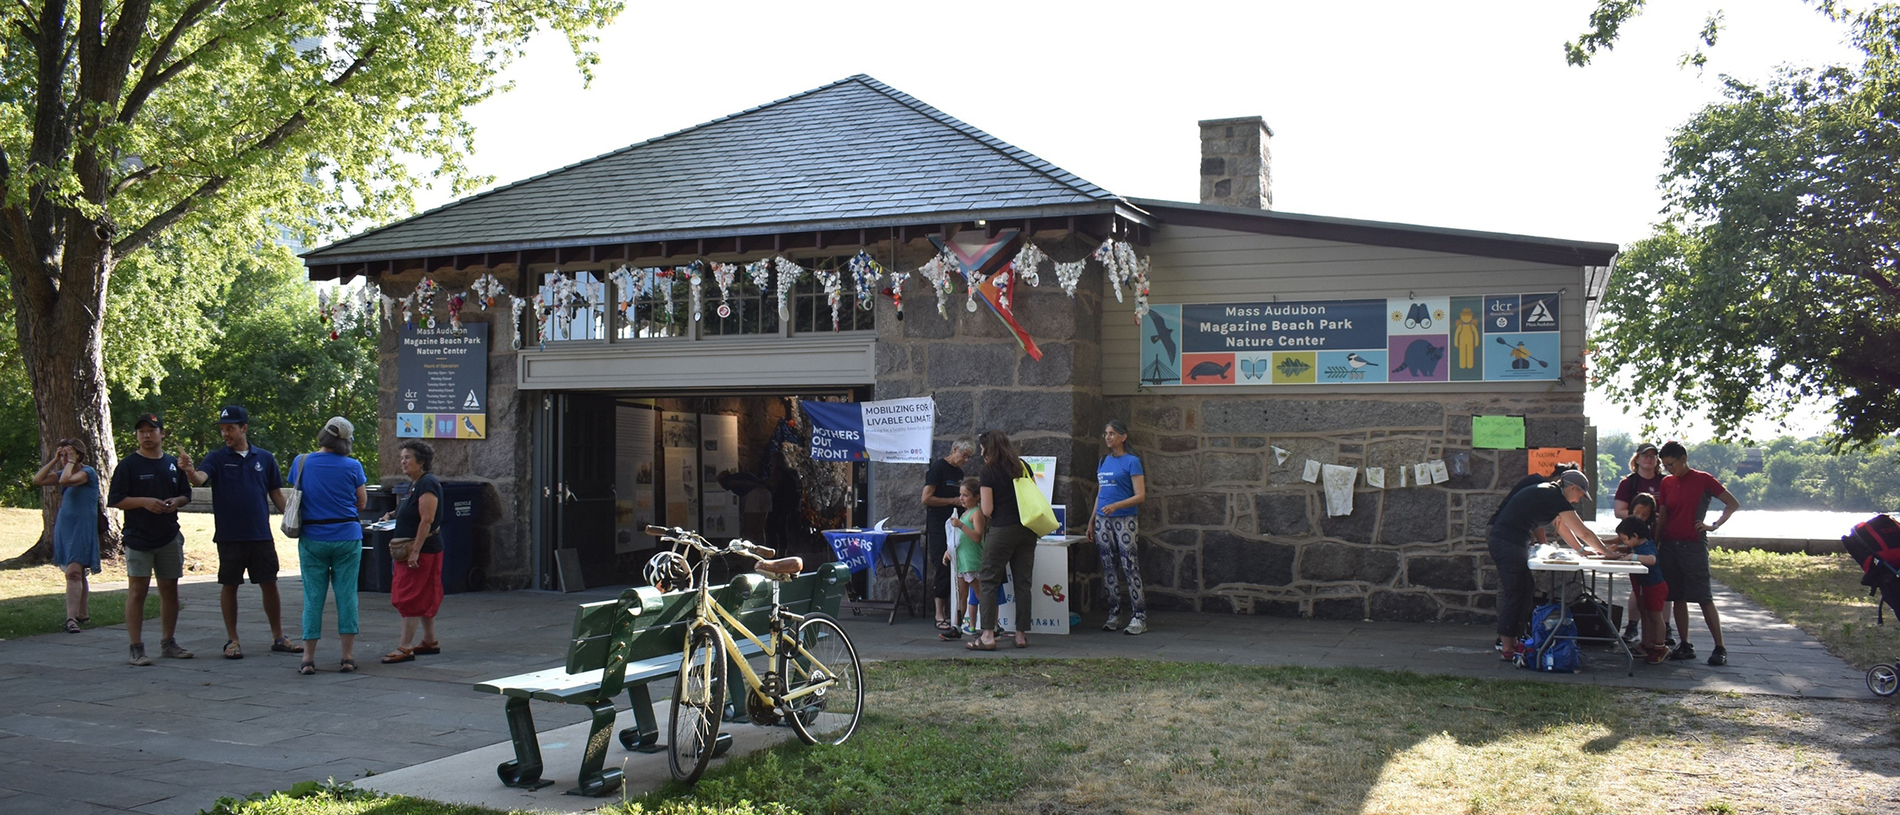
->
179, 405, 304, 659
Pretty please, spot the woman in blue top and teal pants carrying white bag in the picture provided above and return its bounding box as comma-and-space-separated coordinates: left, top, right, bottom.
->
291, 416, 369, 676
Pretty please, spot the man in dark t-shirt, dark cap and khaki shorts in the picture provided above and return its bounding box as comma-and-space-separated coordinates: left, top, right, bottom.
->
106, 414, 192, 667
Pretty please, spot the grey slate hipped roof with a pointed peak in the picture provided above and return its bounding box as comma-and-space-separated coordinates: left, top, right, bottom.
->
304, 74, 1134, 264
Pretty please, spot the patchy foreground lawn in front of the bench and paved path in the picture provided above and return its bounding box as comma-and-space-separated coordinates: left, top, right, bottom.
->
196, 659, 1900, 815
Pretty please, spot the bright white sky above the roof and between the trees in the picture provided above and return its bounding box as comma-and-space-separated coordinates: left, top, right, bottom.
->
422, 0, 1856, 437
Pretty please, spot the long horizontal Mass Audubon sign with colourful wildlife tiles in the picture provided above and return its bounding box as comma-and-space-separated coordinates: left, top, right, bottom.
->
1140, 293, 1564, 388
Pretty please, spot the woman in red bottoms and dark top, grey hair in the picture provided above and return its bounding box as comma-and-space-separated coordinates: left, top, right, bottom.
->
382, 439, 443, 663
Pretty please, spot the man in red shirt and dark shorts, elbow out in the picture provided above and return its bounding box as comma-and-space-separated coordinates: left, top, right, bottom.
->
1657, 441, 1742, 665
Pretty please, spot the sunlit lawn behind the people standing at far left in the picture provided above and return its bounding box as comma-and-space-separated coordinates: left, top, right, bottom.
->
0, 507, 296, 640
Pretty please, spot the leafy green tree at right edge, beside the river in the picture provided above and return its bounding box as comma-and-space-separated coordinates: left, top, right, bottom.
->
1594, 6, 1900, 448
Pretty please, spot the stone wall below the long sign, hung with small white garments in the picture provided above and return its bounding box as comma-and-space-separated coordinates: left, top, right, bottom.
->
1102, 393, 1585, 621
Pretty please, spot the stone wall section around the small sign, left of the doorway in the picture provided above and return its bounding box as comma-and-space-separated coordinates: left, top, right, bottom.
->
371, 270, 534, 589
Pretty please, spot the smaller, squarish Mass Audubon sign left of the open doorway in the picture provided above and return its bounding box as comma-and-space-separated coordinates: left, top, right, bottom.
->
395, 323, 488, 439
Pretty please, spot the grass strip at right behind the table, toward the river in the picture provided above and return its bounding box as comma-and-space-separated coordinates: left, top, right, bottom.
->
1689, 549, 1900, 671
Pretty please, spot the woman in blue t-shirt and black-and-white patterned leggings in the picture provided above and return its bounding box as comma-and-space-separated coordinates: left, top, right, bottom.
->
1083, 418, 1148, 635
